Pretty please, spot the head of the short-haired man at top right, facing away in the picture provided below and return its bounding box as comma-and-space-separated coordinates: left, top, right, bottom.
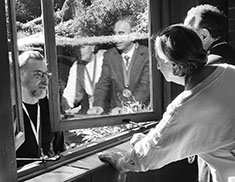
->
184, 4, 227, 50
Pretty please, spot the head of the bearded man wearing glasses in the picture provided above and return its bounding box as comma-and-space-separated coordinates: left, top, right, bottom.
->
19, 51, 51, 104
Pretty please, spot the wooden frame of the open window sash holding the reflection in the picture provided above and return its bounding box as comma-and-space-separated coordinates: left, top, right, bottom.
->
41, 0, 163, 131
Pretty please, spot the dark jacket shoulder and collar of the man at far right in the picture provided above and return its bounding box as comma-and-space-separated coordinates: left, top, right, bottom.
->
208, 40, 235, 65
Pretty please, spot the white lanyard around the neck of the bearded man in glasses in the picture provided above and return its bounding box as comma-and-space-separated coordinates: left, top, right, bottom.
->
22, 103, 40, 146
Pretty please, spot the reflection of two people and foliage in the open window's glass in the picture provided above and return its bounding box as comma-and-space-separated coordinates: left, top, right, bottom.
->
55, 0, 152, 120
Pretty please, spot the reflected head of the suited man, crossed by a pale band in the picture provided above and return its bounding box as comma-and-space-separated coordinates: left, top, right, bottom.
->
113, 16, 134, 52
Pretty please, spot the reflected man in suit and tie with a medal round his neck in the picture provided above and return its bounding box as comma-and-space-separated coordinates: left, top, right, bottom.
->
88, 16, 150, 115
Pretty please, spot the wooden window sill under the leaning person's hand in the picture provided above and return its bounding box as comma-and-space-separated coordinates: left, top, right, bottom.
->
18, 122, 157, 182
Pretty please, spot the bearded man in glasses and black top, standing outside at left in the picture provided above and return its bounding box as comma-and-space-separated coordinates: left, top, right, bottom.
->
16, 51, 65, 167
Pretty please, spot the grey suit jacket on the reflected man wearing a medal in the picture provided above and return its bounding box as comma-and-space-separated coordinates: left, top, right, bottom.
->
93, 45, 150, 111
